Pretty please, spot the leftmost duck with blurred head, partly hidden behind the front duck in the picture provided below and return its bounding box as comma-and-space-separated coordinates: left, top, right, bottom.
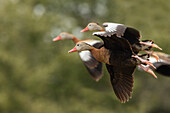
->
53, 32, 103, 81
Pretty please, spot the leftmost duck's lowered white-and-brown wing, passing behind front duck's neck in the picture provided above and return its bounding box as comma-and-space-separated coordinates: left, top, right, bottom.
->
79, 40, 103, 81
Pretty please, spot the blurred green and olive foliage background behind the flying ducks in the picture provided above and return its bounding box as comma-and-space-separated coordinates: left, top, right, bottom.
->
0, 0, 170, 113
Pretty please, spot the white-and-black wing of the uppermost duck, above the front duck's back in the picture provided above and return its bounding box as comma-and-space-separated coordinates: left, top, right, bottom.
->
103, 23, 140, 45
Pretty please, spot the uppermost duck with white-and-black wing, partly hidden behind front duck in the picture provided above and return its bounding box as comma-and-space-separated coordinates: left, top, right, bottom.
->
81, 23, 162, 57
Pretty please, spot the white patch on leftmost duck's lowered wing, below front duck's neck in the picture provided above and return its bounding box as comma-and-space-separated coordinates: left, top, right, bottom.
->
79, 51, 91, 61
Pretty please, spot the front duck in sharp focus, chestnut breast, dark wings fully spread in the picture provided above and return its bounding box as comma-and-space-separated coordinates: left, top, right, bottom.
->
69, 32, 157, 103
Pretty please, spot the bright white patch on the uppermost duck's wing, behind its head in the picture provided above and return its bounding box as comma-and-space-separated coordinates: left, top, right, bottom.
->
103, 23, 124, 32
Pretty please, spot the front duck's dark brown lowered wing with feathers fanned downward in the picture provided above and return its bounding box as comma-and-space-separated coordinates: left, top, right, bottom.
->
106, 64, 136, 103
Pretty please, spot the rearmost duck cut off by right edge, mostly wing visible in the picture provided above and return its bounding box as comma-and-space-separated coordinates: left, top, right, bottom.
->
138, 52, 170, 76
